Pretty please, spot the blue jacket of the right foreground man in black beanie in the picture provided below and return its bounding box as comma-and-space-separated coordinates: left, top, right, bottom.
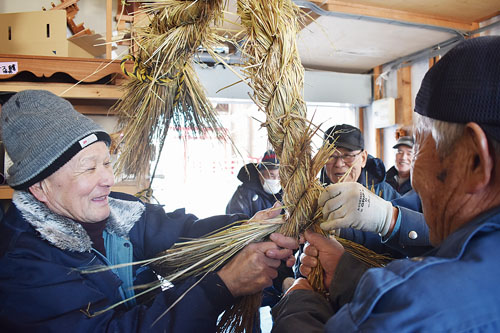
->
326, 207, 500, 332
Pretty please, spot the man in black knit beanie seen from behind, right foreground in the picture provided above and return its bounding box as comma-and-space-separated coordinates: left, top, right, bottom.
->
273, 36, 500, 332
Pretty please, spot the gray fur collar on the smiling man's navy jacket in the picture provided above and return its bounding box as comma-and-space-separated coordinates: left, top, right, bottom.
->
12, 191, 145, 252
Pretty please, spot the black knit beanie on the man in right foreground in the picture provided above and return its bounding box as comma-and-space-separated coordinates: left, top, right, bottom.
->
415, 36, 500, 141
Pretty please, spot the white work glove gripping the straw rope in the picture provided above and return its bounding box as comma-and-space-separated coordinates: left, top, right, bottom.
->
318, 182, 393, 237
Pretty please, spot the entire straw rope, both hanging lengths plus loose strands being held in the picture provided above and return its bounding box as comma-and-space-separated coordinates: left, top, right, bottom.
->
95, 0, 390, 332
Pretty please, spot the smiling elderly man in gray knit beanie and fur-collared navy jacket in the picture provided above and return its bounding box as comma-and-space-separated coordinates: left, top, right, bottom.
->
0, 90, 298, 332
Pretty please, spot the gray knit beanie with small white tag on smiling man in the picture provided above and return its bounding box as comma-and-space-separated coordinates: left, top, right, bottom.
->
0, 90, 111, 189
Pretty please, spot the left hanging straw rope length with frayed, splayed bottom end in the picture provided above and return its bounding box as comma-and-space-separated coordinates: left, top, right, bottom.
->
113, 0, 227, 178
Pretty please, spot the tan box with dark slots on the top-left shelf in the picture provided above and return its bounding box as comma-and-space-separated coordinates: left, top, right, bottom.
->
0, 10, 94, 58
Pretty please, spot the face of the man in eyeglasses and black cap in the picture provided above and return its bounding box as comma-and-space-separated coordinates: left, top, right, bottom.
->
325, 147, 368, 183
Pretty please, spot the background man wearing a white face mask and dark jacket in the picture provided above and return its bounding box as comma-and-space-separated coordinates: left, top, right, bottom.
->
226, 150, 281, 216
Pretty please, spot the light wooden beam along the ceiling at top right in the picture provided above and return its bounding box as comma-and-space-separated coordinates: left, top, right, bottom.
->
310, 0, 474, 31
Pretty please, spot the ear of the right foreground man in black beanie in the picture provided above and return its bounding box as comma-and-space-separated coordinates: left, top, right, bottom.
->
462, 122, 494, 194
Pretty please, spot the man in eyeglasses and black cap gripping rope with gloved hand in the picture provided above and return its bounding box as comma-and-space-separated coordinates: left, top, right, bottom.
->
320, 124, 429, 258
